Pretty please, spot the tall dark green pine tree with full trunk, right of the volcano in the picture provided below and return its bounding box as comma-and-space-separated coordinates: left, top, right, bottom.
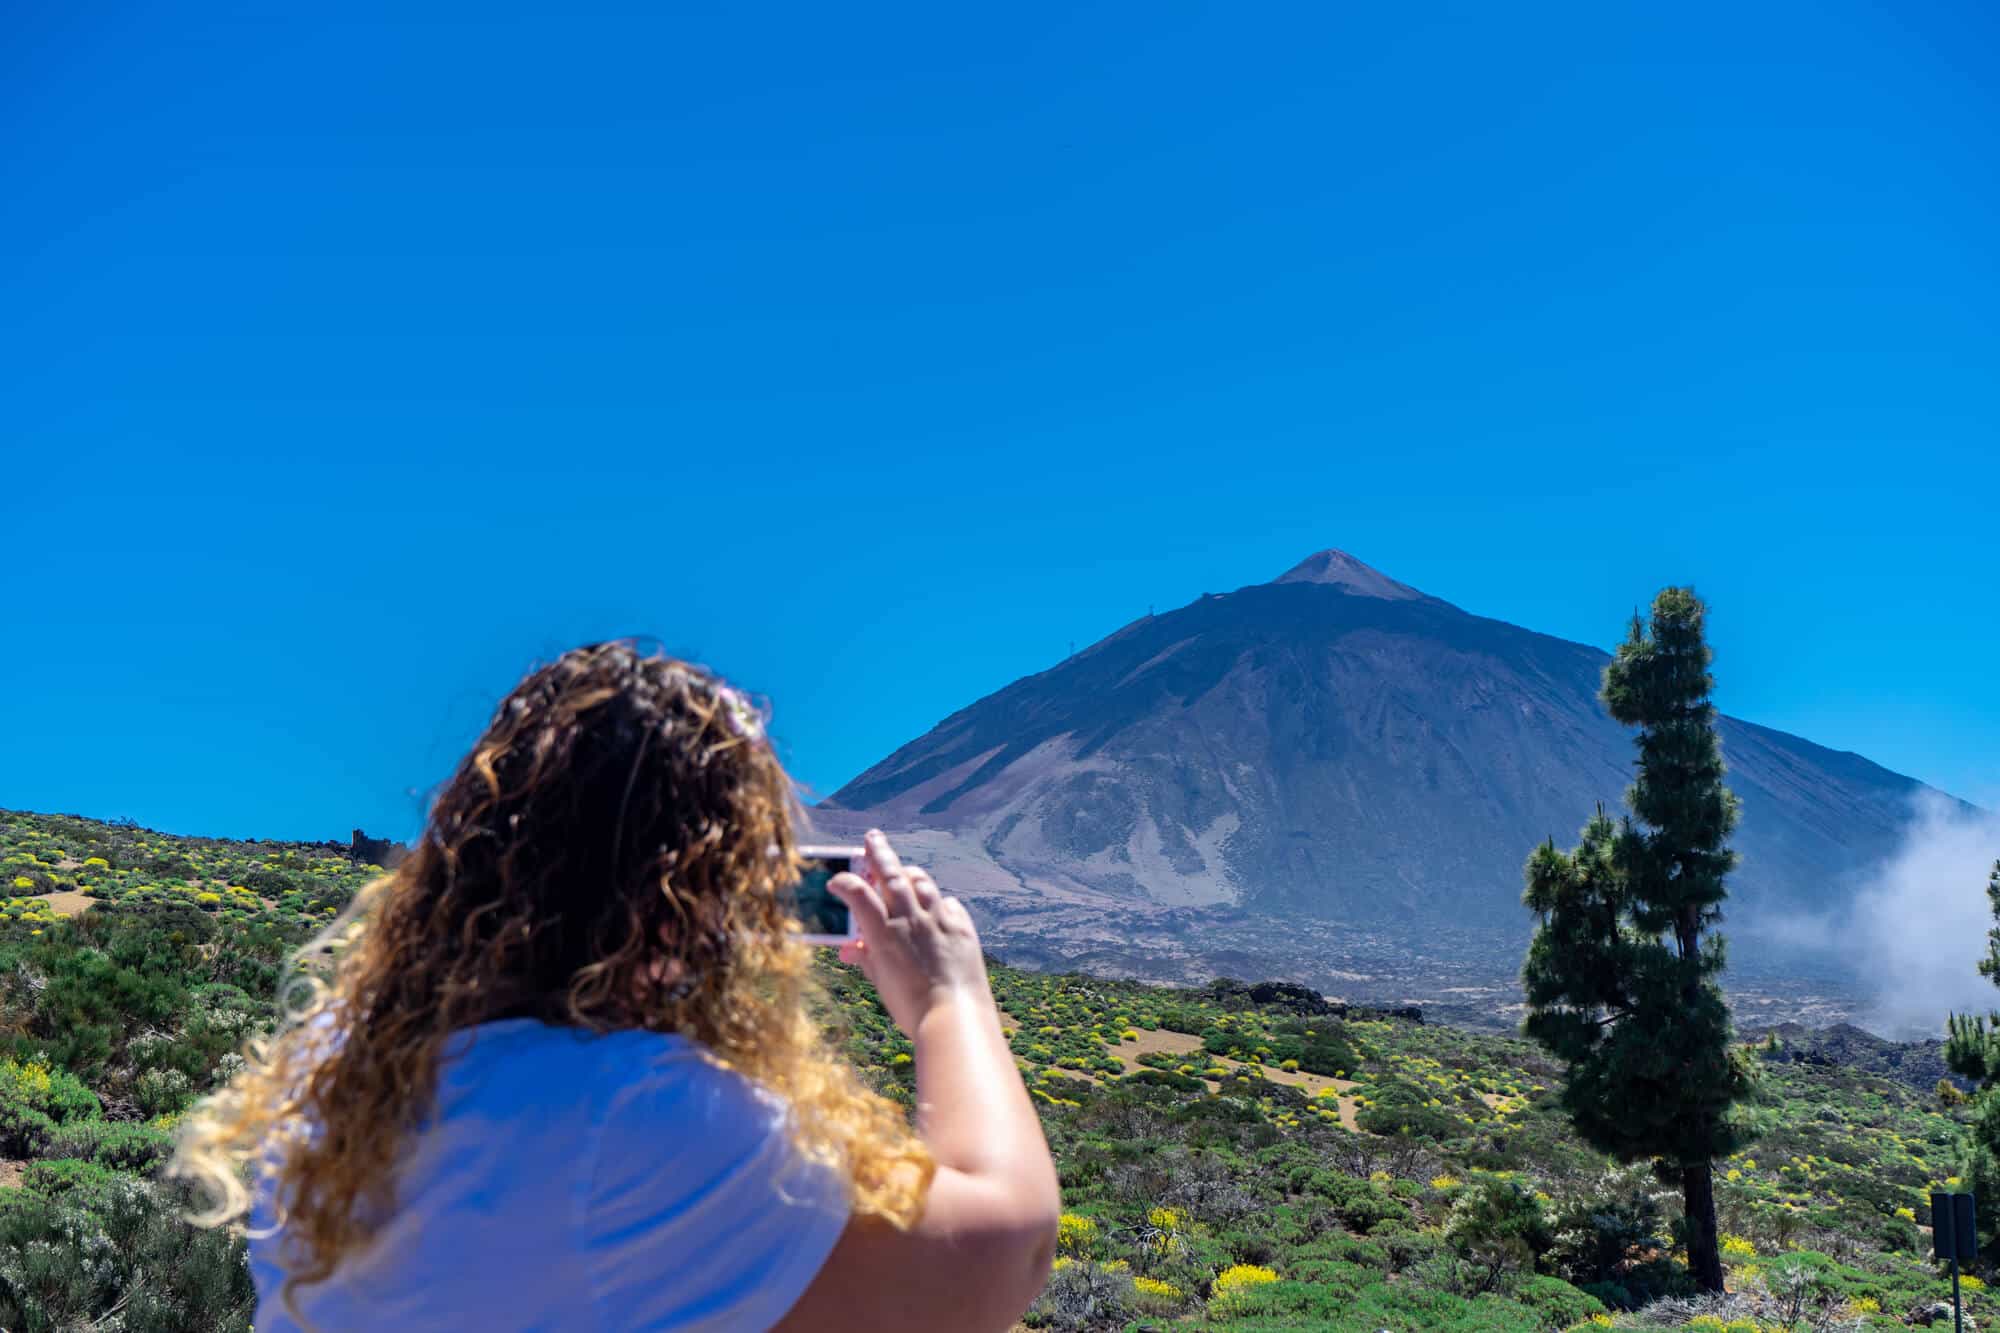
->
1522, 588, 1750, 1291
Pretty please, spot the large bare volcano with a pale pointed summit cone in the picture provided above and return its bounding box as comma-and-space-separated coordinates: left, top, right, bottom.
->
816, 550, 1968, 996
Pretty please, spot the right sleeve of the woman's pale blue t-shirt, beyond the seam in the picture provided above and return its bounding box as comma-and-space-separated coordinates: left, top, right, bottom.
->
578, 1049, 848, 1333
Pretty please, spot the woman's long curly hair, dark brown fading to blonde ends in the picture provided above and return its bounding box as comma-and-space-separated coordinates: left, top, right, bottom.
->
174, 640, 934, 1305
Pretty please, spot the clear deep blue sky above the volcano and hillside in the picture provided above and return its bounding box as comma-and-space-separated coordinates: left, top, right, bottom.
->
0, 0, 2000, 837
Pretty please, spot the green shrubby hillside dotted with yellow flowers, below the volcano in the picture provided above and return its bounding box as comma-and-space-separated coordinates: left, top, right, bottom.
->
0, 813, 2000, 1333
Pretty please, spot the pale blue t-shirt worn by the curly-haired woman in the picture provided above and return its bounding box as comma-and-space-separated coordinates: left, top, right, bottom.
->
250, 1019, 848, 1333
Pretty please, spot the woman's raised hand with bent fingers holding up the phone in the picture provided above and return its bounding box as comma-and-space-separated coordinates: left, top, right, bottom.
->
826, 829, 992, 1039
